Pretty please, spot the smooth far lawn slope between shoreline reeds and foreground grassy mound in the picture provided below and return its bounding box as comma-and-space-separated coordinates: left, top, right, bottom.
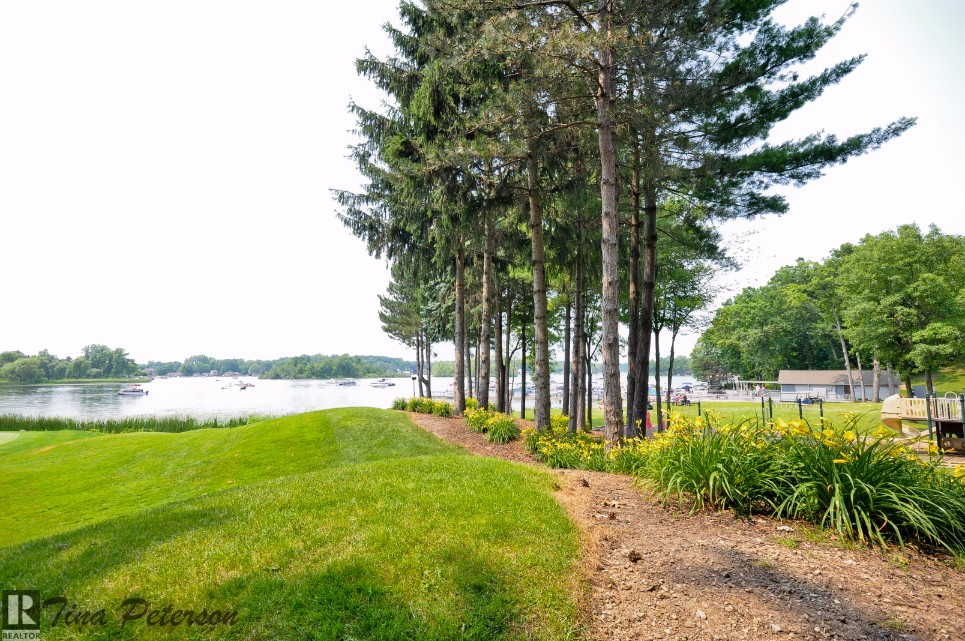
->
0, 409, 455, 545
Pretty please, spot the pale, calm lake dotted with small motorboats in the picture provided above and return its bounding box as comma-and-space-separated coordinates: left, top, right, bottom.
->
0, 376, 693, 420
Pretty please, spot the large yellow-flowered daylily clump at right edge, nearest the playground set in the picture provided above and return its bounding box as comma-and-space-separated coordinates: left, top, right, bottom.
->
775, 423, 965, 554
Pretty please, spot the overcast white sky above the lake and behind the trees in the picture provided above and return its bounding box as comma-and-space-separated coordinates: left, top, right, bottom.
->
0, 0, 965, 362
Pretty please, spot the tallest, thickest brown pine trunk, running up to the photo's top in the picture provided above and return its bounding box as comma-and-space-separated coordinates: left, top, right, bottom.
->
595, 0, 623, 449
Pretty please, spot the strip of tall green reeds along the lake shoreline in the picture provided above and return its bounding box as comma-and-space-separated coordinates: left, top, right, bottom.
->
0, 414, 270, 434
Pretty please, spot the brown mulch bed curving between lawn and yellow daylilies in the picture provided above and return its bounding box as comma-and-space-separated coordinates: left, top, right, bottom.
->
410, 413, 965, 641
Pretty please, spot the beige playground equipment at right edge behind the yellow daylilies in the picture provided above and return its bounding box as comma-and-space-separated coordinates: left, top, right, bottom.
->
881, 394, 965, 452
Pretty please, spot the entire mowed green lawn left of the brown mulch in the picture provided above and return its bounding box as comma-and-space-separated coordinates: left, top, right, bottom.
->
0, 409, 579, 639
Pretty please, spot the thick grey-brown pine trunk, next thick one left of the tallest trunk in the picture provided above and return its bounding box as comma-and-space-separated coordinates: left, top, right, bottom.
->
523, 149, 550, 430
